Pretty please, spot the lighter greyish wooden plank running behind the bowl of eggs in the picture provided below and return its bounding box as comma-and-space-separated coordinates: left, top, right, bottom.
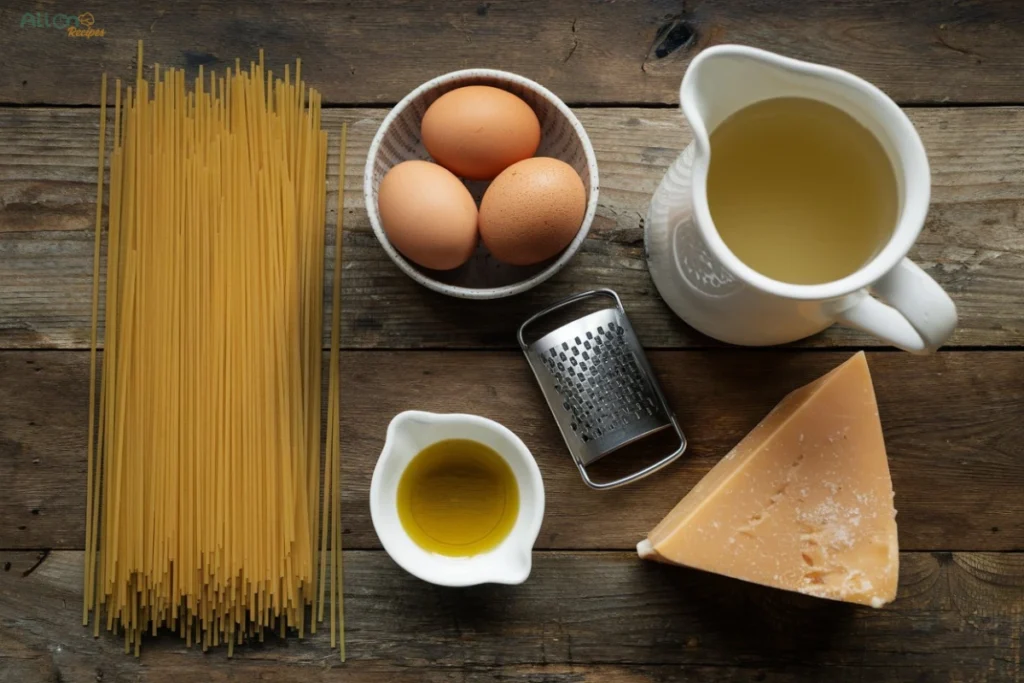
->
0, 108, 1024, 348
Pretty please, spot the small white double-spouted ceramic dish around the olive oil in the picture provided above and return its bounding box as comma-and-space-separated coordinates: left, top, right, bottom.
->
370, 411, 544, 587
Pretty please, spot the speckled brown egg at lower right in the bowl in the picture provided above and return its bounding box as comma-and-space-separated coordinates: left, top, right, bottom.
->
480, 157, 587, 265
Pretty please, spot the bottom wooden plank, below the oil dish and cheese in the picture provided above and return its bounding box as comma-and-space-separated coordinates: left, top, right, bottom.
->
0, 551, 1024, 683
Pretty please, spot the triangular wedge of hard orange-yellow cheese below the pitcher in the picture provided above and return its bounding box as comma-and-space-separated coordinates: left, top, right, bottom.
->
637, 352, 899, 607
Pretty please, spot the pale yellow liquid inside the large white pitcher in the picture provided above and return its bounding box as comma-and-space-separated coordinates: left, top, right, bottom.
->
708, 97, 899, 285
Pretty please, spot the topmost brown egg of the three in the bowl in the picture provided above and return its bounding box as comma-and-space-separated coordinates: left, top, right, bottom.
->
420, 85, 541, 180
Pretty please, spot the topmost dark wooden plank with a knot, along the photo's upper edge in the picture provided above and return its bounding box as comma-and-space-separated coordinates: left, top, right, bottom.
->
0, 0, 1024, 104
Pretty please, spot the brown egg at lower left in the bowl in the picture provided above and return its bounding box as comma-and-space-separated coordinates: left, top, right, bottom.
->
377, 161, 477, 270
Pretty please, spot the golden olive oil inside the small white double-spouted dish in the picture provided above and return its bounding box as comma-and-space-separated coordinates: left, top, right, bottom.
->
398, 439, 519, 557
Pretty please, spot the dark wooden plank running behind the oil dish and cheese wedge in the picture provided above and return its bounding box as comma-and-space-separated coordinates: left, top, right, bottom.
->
0, 350, 1024, 550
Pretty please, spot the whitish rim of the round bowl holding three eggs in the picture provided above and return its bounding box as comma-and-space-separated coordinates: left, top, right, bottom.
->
362, 69, 600, 300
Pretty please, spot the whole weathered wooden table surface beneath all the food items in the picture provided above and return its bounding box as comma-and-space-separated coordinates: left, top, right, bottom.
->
0, 0, 1024, 683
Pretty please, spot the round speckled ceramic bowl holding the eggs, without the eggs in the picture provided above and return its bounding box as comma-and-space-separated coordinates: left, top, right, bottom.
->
362, 69, 599, 299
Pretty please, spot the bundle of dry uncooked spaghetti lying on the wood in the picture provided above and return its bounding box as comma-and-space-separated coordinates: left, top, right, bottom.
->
83, 43, 344, 658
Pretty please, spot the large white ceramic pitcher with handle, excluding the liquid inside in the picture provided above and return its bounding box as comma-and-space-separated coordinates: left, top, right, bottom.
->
644, 45, 956, 353
